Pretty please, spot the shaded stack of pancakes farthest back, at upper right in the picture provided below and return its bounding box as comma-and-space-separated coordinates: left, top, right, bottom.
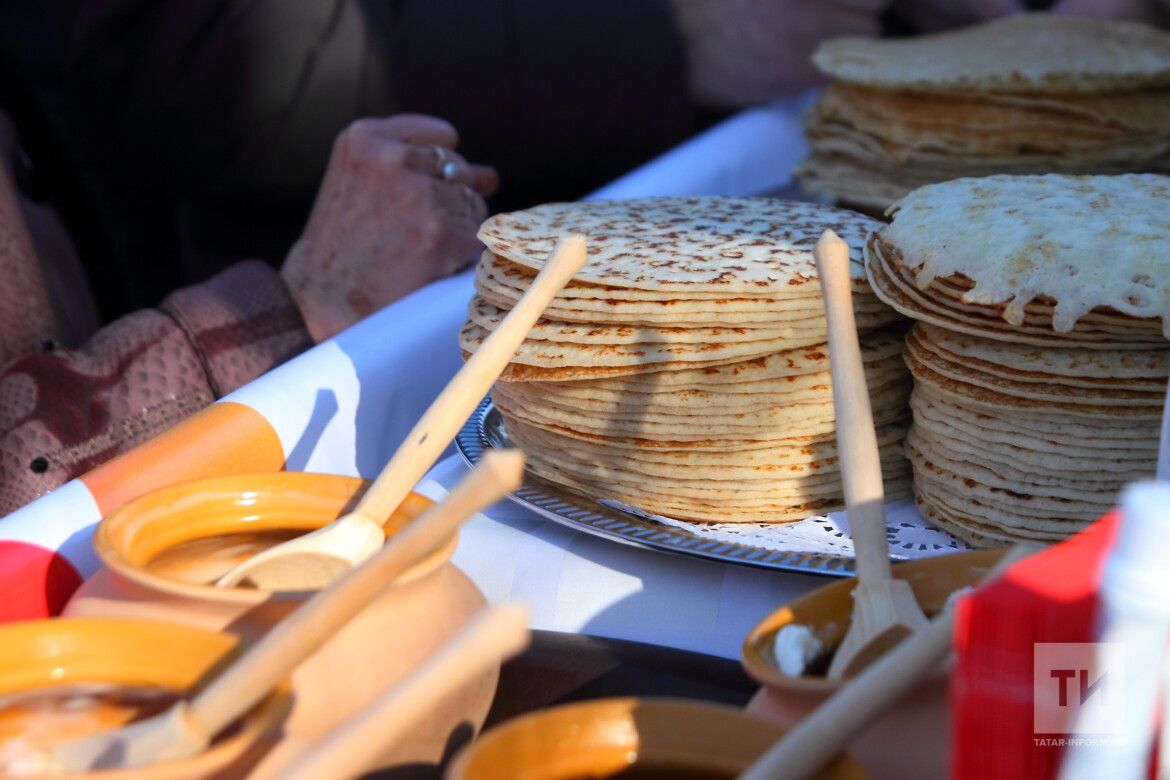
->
798, 14, 1170, 213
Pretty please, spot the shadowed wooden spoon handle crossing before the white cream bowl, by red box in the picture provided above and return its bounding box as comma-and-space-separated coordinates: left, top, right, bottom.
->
739, 544, 1039, 780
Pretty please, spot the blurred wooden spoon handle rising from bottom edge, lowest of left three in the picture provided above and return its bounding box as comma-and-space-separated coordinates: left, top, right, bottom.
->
281, 605, 529, 780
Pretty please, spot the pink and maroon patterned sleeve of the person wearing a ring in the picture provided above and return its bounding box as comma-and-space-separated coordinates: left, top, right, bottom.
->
0, 262, 312, 516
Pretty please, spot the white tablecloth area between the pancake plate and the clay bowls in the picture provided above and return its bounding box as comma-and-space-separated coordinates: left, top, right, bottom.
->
421, 455, 825, 658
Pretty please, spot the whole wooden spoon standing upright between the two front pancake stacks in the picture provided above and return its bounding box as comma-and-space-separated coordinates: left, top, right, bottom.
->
813, 230, 927, 678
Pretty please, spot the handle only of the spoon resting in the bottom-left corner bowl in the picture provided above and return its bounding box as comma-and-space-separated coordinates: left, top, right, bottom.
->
190, 450, 524, 734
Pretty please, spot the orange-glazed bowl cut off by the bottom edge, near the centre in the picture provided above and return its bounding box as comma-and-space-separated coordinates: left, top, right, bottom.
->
446, 698, 865, 780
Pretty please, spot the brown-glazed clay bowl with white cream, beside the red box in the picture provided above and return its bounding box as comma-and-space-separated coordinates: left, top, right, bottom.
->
743, 550, 1004, 778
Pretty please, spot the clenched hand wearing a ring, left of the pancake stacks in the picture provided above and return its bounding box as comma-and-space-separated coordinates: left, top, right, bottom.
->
281, 115, 498, 341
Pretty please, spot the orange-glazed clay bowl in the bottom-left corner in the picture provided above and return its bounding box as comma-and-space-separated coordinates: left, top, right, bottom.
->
0, 619, 290, 780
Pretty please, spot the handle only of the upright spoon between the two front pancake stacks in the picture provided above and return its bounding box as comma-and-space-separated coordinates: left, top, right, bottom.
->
813, 230, 890, 582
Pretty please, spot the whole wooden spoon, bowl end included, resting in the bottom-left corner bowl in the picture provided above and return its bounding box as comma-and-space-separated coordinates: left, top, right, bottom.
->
42, 450, 524, 772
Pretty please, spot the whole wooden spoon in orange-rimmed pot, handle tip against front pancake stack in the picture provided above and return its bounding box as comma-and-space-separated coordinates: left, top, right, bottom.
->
215, 236, 586, 591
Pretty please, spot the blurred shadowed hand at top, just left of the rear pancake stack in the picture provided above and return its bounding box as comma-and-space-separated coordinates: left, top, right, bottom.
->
674, 0, 889, 106
